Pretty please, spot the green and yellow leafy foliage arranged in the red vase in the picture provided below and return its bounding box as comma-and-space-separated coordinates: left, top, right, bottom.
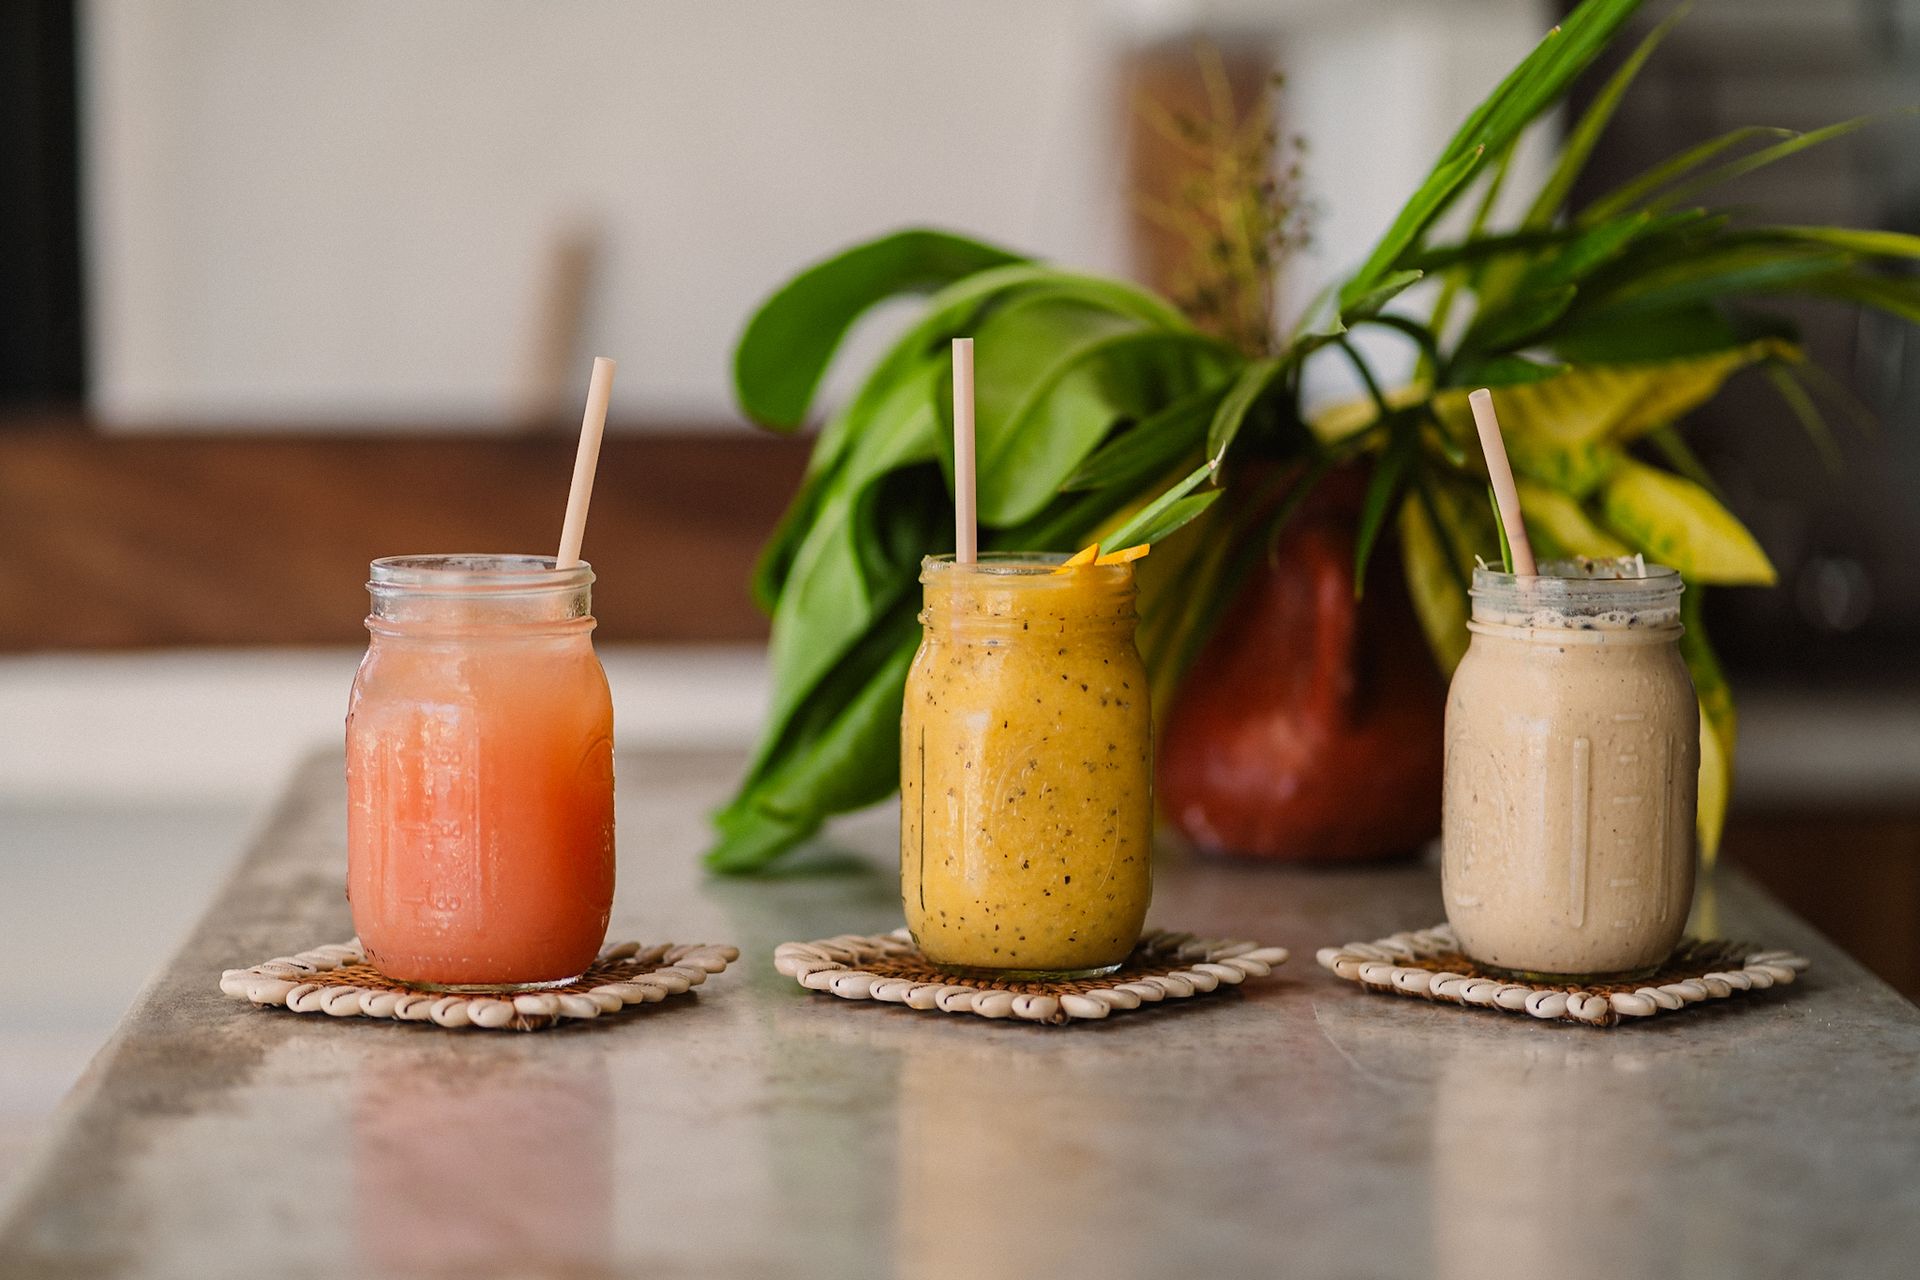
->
708, 0, 1920, 871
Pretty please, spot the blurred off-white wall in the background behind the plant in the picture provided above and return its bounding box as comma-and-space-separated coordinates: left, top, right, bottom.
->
83, 0, 1542, 426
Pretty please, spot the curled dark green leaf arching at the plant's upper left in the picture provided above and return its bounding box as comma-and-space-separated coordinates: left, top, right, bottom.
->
733, 228, 1023, 432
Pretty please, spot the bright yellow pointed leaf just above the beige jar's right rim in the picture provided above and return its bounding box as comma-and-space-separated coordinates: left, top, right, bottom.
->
1599, 459, 1774, 587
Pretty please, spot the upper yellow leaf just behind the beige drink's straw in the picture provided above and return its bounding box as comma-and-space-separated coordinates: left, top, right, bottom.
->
1434, 338, 1797, 497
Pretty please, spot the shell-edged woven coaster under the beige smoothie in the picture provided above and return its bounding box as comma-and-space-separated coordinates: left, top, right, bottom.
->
1317, 925, 1807, 1027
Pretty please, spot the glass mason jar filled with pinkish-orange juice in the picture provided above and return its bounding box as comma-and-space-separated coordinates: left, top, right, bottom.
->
348, 555, 614, 990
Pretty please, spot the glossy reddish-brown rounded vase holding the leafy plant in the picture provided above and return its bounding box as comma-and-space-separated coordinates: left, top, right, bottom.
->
1158, 468, 1446, 862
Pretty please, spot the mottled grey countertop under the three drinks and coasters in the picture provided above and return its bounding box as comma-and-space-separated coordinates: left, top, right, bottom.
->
0, 750, 1920, 1280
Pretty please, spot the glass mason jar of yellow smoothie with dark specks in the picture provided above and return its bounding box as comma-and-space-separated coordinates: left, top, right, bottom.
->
900, 555, 1154, 977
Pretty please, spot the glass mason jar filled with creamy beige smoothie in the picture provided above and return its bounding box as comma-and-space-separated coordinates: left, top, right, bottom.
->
1440, 558, 1699, 979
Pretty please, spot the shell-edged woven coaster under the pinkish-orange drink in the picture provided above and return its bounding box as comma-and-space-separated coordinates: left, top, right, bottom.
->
221, 938, 739, 1031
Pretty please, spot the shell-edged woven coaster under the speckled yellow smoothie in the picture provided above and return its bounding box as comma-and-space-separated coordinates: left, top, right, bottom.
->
774, 929, 1286, 1027
